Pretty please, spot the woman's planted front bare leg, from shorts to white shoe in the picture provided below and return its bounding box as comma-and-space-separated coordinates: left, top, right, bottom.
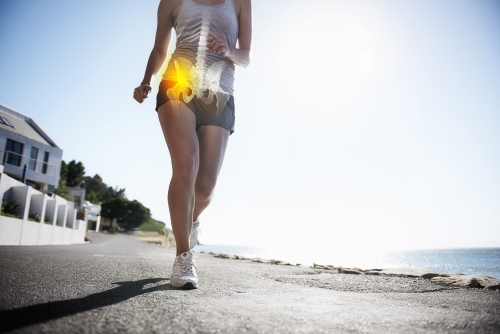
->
158, 101, 200, 255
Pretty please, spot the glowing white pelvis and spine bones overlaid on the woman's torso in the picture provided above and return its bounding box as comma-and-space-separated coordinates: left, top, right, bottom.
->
167, 17, 229, 115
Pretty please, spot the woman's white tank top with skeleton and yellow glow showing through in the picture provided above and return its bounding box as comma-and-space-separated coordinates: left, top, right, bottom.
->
163, 0, 238, 98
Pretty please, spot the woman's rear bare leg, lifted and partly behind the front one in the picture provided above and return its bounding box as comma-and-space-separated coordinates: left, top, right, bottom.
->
193, 125, 229, 221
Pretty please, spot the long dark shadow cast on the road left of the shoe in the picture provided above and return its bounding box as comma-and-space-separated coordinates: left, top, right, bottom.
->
0, 278, 177, 333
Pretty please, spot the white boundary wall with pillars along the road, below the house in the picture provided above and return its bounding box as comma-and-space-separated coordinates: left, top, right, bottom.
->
0, 165, 87, 245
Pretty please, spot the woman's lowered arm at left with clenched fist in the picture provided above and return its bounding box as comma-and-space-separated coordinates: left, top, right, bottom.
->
134, 0, 176, 103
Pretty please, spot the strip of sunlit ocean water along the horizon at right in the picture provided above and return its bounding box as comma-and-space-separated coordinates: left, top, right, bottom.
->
195, 245, 500, 279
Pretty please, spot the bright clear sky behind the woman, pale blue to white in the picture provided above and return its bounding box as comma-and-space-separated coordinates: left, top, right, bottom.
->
0, 0, 500, 251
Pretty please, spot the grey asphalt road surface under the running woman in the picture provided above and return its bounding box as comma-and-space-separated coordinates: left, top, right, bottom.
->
0, 234, 500, 333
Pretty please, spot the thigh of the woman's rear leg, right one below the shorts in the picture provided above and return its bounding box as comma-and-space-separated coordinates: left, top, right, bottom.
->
196, 125, 229, 188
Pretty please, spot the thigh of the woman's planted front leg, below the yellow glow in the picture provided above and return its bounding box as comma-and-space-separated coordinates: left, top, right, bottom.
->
158, 101, 199, 173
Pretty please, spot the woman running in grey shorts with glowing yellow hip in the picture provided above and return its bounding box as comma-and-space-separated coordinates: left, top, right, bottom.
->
134, 0, 252, 288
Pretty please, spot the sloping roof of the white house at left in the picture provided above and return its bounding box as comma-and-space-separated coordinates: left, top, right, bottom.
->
0, 103, 60, 149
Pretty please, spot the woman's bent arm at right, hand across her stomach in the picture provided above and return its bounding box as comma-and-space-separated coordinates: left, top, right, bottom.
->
207, 0, 252, 67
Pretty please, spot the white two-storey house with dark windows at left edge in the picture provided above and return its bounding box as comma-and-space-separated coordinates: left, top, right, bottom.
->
0, 104, 63, 192
